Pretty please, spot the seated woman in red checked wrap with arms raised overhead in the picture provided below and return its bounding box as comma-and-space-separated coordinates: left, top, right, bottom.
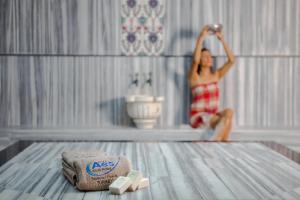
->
188, 26, 234, 141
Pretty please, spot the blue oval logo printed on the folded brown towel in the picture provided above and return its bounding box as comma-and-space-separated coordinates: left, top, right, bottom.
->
86, 157, 120, 176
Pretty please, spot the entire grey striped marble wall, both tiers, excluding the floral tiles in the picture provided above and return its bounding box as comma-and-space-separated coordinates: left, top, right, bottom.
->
0, 0, 300, 129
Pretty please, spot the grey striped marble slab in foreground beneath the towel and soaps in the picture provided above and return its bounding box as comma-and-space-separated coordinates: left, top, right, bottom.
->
0, 142, 300, 200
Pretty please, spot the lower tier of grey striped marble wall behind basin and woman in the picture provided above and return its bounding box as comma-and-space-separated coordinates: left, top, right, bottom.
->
0, 56, 300, 129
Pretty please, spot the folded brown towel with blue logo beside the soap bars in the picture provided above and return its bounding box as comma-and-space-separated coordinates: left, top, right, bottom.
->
62, 151, 131, 190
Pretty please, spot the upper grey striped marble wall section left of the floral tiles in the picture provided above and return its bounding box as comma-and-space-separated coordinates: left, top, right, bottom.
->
0, 0, 121, 55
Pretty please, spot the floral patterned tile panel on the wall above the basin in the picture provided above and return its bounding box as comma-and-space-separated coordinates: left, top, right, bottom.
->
121, 0, 165, 55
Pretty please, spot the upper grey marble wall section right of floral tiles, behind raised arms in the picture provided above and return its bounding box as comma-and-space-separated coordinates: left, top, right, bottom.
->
165, 0, 300, 56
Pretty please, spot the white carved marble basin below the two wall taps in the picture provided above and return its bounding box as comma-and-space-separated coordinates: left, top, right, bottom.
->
126, 95, 164, 129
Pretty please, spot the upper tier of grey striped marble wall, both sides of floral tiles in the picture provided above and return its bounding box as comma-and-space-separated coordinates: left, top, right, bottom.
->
0, 0, 300, 55
